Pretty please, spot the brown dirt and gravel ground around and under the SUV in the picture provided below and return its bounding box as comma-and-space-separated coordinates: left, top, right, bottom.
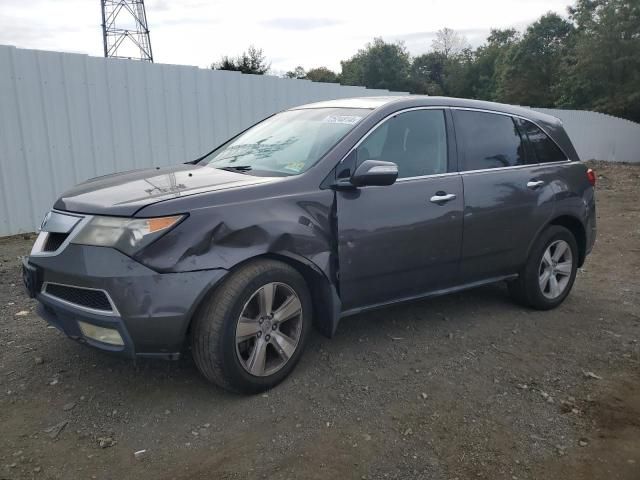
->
0, 159, 640, 480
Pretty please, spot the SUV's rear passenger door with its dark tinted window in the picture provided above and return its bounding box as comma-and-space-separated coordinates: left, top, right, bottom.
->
452, 109, 554, 283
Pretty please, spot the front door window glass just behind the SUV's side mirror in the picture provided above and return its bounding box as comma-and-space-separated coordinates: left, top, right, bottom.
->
356, 110, 447, 178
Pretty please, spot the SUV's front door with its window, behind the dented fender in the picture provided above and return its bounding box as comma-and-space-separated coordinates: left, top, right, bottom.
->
337, 109, 463, 310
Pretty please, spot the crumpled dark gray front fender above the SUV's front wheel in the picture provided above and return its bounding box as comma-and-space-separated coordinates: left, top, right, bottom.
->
135, 190, 341, 336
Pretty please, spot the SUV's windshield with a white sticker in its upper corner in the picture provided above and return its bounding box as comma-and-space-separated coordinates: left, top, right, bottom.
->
200, 108, 369, 176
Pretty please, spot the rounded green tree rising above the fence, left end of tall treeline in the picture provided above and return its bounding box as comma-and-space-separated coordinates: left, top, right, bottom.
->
340, 38, 410, 90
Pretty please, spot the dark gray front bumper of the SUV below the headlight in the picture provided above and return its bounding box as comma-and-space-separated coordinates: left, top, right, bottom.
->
25, 244, 227, 358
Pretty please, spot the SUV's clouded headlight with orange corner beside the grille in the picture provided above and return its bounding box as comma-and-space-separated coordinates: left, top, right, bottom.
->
71, 215, 184, 255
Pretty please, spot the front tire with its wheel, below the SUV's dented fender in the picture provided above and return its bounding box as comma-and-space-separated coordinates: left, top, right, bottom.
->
191, 260, 312, 393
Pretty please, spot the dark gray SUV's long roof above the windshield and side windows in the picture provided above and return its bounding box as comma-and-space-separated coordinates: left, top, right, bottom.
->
291, 95, 560, 124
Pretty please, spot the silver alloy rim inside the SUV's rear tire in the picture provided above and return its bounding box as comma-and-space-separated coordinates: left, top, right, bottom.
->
538, 240, 573, 300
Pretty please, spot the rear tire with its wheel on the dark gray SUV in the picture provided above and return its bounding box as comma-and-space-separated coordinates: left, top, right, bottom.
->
509, 225, 578, 310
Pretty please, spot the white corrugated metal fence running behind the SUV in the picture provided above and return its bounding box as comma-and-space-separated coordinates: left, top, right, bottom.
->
0, 45, 640, 236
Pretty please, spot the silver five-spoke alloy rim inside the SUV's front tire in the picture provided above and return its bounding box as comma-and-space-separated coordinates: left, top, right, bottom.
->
235, 282, 303, 377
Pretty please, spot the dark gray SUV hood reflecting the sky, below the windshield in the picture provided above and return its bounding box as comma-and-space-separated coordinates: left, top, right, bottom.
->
54, 165, 279, 216
